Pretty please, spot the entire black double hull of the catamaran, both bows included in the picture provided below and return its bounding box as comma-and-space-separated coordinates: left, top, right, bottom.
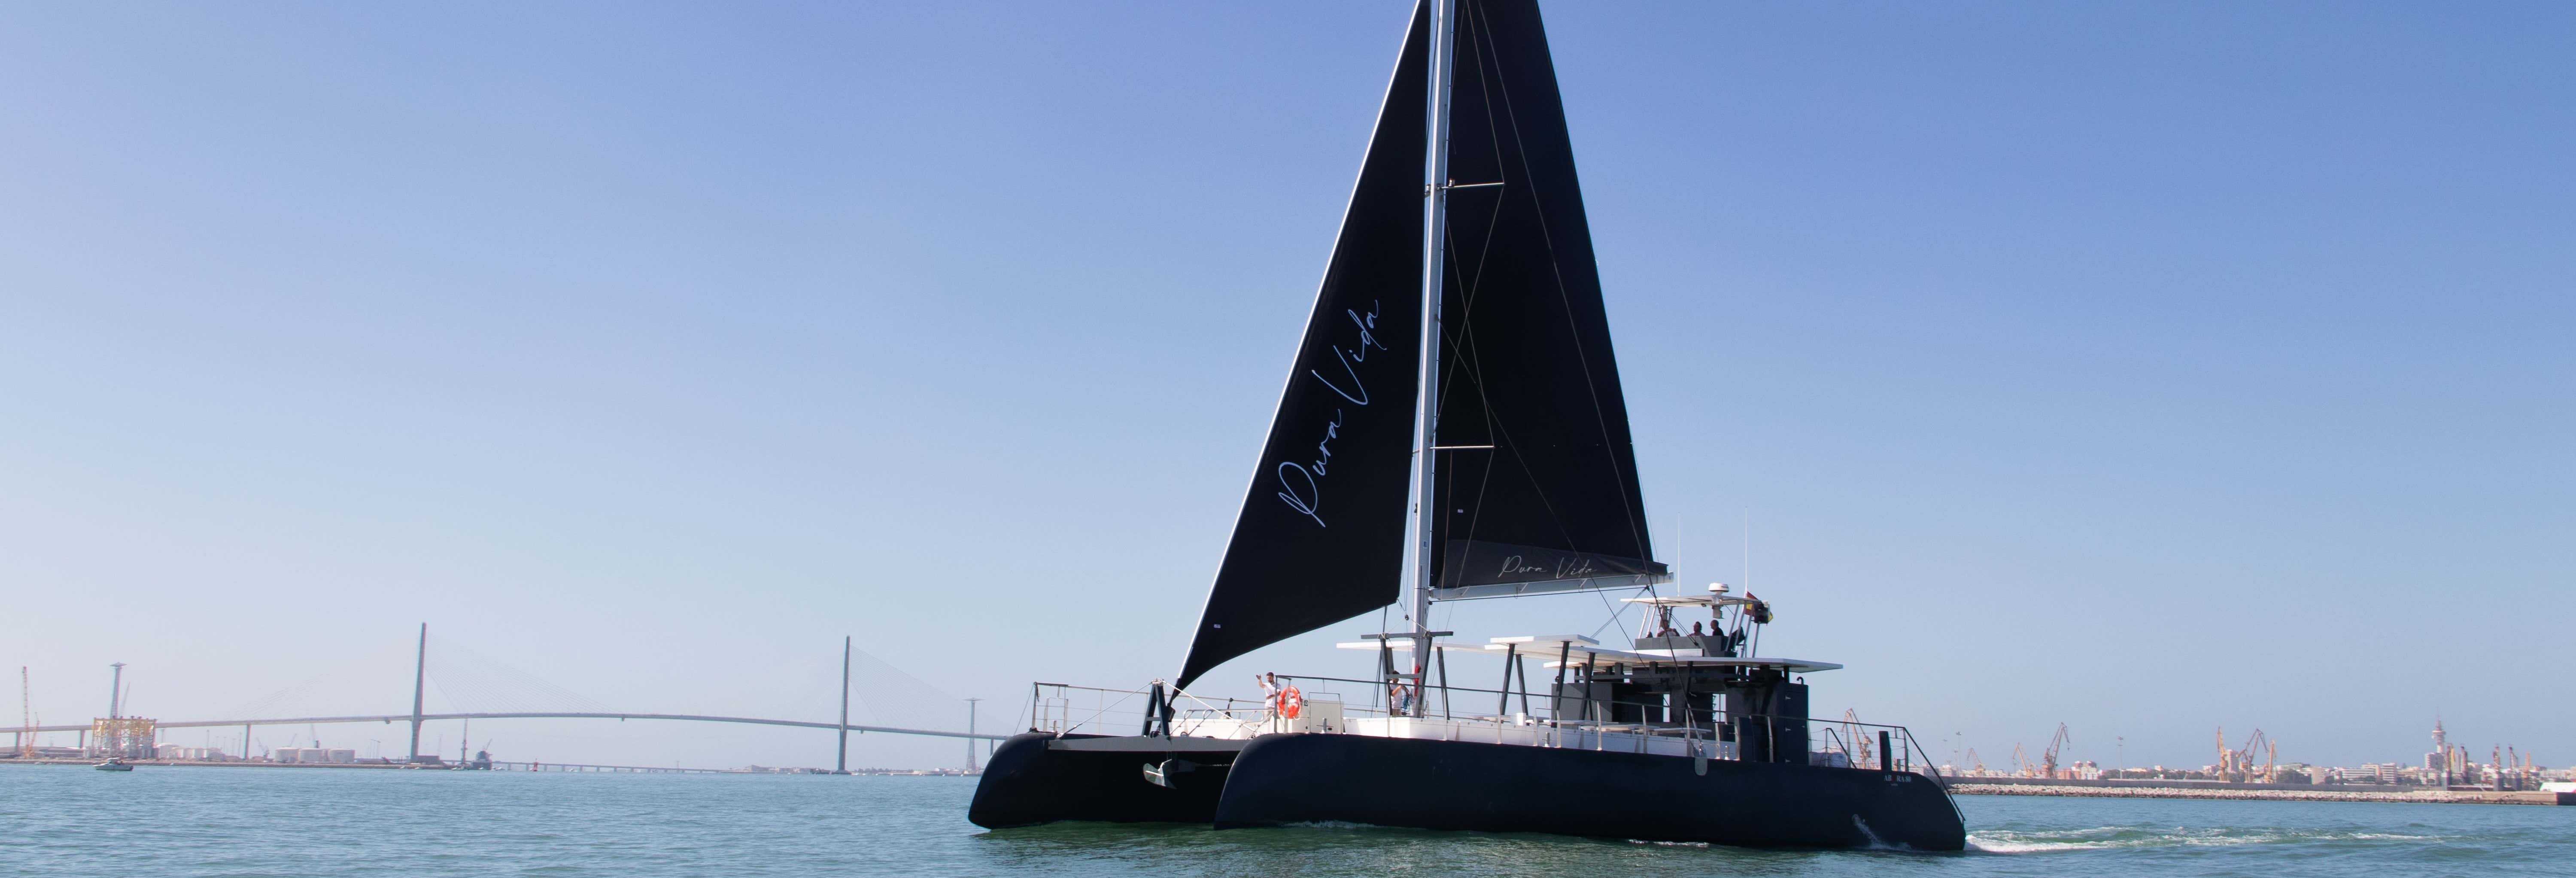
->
969, 734, 1968, 850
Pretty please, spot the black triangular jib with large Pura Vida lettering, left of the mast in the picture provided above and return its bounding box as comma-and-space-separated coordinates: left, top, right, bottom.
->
1175, 5, 1443, 687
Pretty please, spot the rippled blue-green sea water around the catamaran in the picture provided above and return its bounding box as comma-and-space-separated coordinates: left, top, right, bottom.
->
0, 767, 2576, 878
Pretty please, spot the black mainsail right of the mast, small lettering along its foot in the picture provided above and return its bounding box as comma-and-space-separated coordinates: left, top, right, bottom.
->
1432, 0, 1669, 600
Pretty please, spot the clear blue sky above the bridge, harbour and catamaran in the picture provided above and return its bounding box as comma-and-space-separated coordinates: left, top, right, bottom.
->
0, 0, 2576, 767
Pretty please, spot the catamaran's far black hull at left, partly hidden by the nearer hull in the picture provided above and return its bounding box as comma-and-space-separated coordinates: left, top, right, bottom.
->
966, 731, 1244, 829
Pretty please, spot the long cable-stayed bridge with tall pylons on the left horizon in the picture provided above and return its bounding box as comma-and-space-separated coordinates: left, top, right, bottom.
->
5, 623, 1007, 772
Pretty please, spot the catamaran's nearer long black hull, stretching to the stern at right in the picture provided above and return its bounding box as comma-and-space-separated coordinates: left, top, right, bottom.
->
1216, 734, 1968, 850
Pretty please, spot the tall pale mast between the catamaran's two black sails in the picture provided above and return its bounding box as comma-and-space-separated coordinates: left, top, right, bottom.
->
1412, 0, 1458, 716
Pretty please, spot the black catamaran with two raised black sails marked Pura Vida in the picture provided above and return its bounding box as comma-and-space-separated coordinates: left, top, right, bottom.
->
969, 0, 1965, 850
